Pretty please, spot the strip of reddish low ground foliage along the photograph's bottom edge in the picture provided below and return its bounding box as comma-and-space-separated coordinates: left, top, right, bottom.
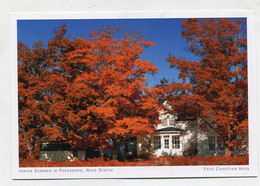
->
19, 155, 249, 167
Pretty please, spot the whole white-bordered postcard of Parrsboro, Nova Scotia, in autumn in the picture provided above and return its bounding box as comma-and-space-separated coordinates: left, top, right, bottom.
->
11, 11, 257, 179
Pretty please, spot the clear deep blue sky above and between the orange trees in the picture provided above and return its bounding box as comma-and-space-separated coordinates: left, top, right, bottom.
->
17, 19, 245, 87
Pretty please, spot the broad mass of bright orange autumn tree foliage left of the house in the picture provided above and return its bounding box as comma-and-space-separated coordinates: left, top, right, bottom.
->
18, 25, 160, 158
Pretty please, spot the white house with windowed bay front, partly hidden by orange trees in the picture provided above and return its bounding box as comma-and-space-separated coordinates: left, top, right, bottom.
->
137, 102, 225, 156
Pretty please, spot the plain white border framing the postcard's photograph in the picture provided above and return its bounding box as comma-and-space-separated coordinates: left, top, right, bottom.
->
11, 11, 257, 179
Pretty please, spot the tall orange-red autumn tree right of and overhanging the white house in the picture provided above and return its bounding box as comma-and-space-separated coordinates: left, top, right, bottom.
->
166, 18, 248, 155
